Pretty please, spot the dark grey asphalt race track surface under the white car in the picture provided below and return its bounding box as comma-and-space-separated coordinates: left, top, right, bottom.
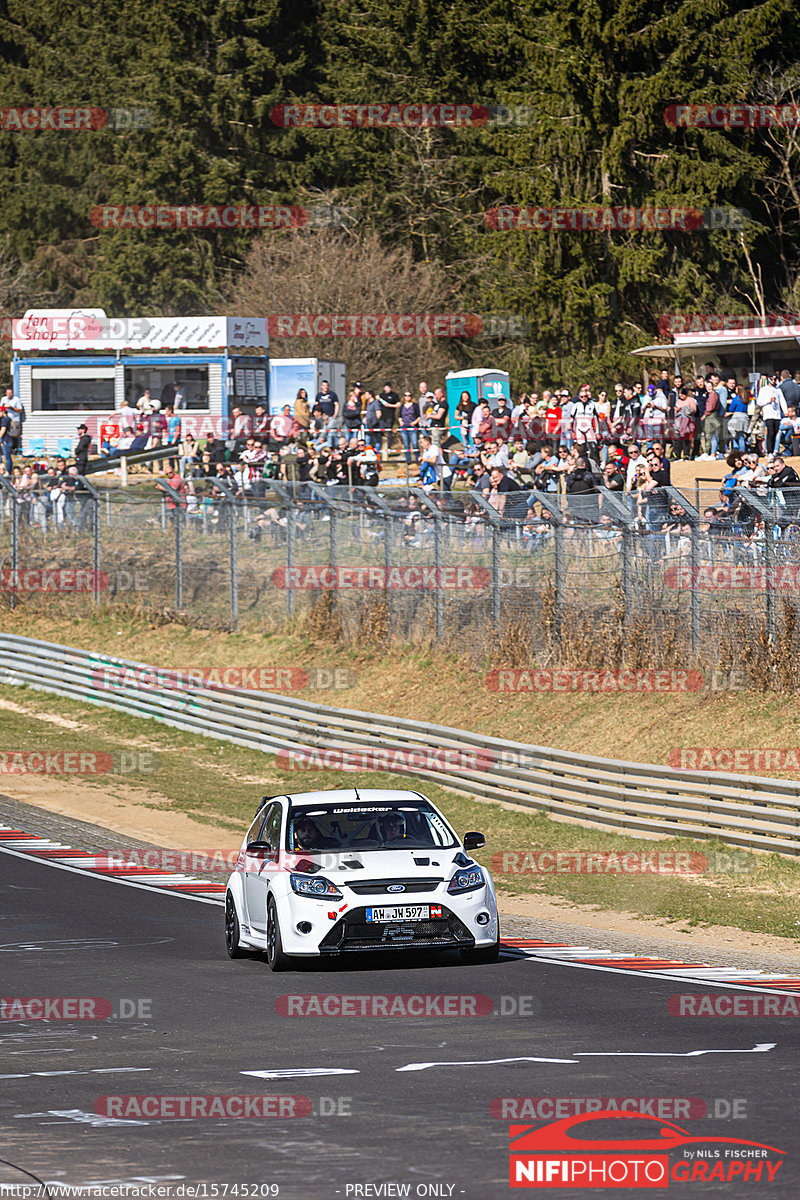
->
0, 852, 800, 1200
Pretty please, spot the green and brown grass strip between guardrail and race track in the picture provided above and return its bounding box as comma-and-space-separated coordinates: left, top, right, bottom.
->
0, 686, 800, 940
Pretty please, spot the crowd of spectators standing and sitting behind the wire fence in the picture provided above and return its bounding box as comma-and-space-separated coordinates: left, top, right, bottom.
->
0, 364, 800, 528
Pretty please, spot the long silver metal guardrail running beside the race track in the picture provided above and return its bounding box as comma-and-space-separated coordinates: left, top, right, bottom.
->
0, 634, 800, 854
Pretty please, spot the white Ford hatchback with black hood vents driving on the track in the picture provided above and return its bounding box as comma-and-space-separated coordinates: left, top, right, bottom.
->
225, 788, 500, 971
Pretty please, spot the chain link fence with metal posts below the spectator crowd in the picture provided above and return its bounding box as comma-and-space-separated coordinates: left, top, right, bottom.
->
0, 478, 800, 666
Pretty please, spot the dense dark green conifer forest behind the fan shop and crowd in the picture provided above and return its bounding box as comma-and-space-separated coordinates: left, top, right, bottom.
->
0, 0, 800, 386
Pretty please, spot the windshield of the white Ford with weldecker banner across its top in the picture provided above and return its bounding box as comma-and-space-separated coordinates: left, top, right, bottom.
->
287, 804, 458, 851
